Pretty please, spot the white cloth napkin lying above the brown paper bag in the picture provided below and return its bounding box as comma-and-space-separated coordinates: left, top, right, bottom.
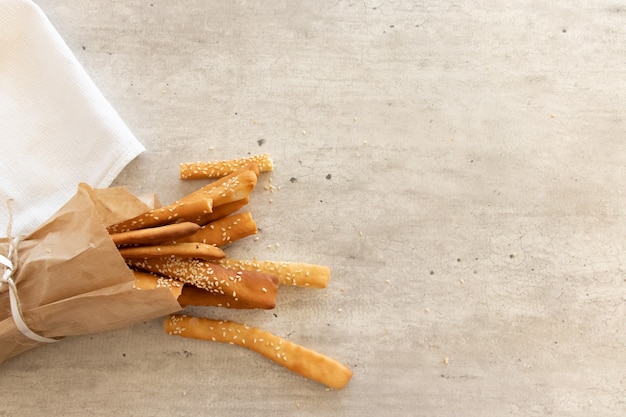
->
0, 0, 145, 237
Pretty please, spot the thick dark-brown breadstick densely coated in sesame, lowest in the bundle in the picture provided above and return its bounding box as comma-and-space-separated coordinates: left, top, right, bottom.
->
126, 256, 278, 308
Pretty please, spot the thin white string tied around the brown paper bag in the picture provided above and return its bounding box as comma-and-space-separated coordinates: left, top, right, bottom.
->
0, 201, 59, 343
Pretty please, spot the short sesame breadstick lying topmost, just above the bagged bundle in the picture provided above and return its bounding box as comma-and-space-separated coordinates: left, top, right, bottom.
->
180, 153, 274, 179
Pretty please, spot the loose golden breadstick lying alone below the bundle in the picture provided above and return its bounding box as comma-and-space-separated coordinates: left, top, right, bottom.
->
163, 314, 352, 389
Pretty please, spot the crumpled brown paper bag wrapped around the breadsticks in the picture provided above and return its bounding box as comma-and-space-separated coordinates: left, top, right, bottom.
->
0, 184, 181, 363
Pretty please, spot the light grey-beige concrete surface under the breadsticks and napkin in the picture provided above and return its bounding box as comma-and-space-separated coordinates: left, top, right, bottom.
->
0, 0, 626, 416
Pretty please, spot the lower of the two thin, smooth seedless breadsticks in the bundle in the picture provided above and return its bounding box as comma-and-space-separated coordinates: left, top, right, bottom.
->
120, 243, 226, 261
